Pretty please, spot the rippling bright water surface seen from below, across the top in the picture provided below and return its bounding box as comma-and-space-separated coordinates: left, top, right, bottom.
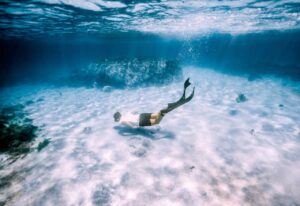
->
0, 0, 300, 38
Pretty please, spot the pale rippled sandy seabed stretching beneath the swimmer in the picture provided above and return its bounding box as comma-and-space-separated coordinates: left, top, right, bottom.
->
0, 68, 300, 206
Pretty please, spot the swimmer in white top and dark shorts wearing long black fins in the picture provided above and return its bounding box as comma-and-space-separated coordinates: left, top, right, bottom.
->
114, 78, 195, 127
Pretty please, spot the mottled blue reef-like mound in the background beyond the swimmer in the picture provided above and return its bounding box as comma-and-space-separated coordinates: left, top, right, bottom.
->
59, 58, 182, 88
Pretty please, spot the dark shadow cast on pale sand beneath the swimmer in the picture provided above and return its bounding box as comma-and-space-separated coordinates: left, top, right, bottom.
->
114, 126, 176, 140
